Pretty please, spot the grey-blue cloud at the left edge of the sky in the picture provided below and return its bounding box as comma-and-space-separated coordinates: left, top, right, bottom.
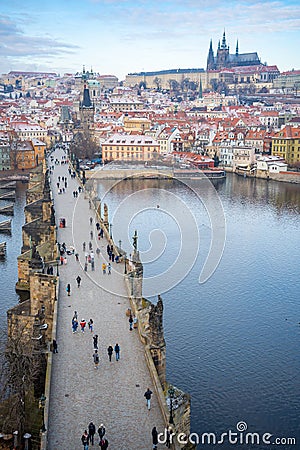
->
0, 15, 79, 58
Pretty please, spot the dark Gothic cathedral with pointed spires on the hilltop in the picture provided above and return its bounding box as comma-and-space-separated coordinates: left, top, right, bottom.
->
207, 31, 263, 70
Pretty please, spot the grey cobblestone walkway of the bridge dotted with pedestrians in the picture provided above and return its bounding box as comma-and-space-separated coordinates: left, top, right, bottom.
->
47, 149, 164, 450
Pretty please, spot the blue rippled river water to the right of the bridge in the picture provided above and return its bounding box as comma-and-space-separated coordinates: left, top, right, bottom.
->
98, 174, 300, 449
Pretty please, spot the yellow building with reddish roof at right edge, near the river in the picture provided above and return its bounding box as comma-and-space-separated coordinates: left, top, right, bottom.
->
272, 125, 300, 164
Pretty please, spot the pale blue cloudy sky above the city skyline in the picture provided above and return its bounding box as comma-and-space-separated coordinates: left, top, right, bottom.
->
0, 0, 300, 80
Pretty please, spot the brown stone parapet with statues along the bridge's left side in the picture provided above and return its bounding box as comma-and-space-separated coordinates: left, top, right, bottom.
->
3, 163, 59, 449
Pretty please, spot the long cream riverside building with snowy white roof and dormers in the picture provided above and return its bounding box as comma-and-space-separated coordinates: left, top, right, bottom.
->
102, 134, 160, 162
